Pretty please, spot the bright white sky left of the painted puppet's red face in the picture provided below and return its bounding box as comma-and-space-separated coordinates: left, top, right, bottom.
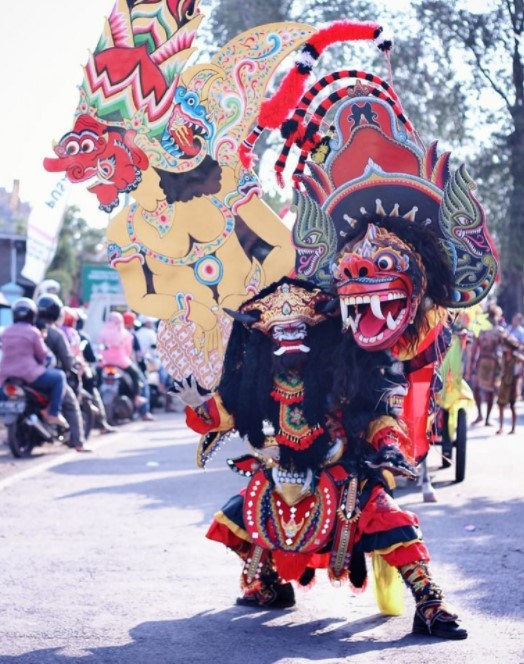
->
0, 0, 488, 227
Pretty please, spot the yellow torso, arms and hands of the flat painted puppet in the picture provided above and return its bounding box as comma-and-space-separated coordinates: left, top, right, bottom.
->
107, 164, 294, 386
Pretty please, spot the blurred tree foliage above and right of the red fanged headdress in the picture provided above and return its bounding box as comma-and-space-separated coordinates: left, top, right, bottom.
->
201, 0, 524, 316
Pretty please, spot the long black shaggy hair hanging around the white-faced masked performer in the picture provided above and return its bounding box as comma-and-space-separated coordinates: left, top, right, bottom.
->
218, 277, 402, 471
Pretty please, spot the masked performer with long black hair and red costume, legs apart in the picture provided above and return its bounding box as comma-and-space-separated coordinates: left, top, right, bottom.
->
177, 278, 467, 639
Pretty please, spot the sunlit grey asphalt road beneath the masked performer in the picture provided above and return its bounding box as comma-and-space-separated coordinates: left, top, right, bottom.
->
0, 404, 524, 664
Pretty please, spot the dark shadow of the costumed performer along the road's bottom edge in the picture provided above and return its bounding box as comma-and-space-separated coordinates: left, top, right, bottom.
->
0, 607, 450, 664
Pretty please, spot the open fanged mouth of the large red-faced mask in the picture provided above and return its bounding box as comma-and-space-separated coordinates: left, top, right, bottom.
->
339, 290, 410, 350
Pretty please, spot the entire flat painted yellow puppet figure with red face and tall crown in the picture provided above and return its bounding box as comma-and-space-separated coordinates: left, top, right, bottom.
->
44, 0, 316, 387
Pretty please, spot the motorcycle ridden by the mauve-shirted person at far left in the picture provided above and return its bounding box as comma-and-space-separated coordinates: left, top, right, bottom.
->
0, 378, 69, 459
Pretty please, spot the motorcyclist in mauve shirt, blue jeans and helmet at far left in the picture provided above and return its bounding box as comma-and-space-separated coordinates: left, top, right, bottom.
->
0, 297, 66, 425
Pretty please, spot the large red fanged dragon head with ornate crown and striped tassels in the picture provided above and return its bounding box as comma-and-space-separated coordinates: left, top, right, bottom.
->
276, 77, 497, 350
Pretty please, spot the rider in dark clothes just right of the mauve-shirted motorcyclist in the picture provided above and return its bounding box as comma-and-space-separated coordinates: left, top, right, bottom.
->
36, 293, 90, 452
